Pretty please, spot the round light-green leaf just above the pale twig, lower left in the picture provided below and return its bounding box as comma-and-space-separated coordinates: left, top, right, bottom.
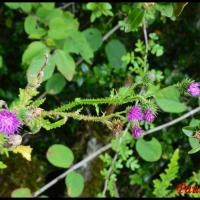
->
47, 144, 74, 168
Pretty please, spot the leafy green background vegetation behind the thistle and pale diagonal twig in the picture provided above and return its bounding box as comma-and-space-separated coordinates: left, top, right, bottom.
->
0, 2, 200, 197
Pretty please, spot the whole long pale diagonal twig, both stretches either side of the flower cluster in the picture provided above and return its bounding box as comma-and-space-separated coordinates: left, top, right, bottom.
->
33, 106, 200, 197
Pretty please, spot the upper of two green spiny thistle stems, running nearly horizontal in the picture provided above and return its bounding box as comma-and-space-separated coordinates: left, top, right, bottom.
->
53, 96, 146, 112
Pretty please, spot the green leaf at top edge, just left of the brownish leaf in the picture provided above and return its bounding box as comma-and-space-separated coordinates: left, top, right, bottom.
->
155, 2, 174, 17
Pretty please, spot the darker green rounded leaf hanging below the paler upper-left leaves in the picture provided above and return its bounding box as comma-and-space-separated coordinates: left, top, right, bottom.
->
45, 73, 66, 95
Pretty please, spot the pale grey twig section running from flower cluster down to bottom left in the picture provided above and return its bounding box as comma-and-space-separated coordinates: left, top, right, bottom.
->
33, 144, 111, 197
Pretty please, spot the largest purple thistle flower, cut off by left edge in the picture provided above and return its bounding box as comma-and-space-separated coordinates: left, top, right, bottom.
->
0, 110, 21, 135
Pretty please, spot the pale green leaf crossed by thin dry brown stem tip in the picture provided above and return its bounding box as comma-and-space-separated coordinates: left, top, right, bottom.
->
26, 54, 55, 83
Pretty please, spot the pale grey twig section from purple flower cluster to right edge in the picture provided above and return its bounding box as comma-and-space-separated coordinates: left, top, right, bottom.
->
144, 106, 200, 135
